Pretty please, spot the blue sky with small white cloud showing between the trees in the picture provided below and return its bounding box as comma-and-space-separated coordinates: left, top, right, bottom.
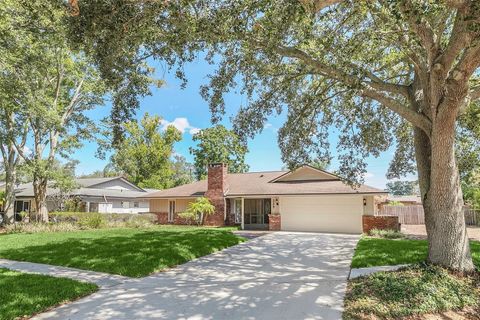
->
72, 59, 408, 188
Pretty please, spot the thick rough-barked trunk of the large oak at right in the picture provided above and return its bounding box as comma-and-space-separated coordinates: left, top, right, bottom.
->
414, 119, 474, 272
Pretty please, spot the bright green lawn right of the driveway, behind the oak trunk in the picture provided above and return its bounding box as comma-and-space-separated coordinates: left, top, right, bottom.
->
352, 237, 480, 268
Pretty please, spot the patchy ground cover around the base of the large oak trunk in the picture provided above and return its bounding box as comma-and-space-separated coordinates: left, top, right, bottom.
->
343, 263, 480, 320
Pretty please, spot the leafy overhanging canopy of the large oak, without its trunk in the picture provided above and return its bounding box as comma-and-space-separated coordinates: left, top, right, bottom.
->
70, 0, 480, 186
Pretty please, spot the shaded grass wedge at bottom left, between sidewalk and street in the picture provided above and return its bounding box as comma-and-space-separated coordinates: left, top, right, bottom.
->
0, 268, 98, 320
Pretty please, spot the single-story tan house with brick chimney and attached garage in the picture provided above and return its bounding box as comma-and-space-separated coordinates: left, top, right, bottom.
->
145, 163, 390, 233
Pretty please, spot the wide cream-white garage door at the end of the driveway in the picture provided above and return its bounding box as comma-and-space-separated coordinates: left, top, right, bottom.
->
280, 195, 363, 233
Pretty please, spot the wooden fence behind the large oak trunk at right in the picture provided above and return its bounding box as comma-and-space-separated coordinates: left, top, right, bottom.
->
376, 205, 480, 226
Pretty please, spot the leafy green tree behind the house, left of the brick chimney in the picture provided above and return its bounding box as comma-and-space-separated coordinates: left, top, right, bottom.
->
111, 113, 182, 189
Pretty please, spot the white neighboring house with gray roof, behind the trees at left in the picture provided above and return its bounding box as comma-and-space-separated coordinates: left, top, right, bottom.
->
14, 177, 153, 213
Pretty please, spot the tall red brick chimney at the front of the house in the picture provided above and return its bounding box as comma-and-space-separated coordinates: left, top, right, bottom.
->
205, 163, 228, 226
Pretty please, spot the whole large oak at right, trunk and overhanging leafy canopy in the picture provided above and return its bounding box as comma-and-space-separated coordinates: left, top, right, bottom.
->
71, 0, 480, 271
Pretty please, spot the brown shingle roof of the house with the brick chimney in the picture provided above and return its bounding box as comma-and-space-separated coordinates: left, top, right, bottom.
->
142, 171, 386, 198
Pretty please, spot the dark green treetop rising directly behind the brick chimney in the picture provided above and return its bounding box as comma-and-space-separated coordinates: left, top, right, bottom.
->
190, 125, 248, 180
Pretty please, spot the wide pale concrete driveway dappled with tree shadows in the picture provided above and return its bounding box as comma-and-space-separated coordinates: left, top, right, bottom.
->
34, 232, 359, 320
